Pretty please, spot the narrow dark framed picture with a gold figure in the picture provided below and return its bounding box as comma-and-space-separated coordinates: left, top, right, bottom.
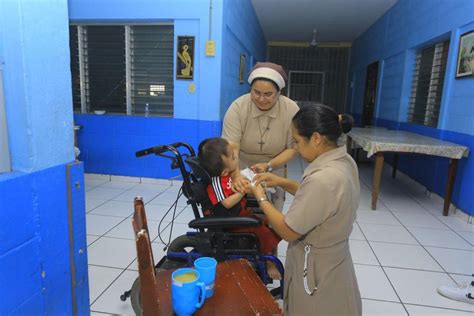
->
176, 36, 194, 80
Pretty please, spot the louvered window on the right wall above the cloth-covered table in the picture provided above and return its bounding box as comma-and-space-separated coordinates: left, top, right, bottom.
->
408, 40, 449, 127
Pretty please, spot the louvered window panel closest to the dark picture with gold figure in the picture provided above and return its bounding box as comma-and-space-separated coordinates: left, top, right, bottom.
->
130, 25, 174, 116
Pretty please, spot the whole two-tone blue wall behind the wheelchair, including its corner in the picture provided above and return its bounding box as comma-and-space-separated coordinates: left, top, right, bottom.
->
69, 0, 265, 178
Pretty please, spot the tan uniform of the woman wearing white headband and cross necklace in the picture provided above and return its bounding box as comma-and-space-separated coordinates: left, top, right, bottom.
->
222, 93, 299, 211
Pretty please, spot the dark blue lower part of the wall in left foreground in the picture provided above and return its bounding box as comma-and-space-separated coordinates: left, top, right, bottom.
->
0, 162, 89, 315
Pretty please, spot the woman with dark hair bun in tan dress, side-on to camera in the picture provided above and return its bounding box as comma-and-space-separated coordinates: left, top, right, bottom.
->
252, 105, 362, 316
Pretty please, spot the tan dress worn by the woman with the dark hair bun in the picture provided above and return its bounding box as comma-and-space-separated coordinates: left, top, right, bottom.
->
284, 146, 362, 316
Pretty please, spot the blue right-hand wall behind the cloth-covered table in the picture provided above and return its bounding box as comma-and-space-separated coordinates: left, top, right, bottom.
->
347, 0, 474, 215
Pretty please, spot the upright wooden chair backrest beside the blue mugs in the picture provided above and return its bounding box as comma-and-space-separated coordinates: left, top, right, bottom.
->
132, 197, 159, 316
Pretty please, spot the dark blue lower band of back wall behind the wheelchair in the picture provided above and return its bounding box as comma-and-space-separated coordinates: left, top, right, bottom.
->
74, 114, 221, 179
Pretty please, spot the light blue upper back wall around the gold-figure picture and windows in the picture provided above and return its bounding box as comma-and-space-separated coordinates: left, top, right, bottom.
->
69, 0, 223, 121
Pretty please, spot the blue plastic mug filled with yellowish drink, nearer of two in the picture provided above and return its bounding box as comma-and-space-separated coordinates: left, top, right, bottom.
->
171, 268, 206, 316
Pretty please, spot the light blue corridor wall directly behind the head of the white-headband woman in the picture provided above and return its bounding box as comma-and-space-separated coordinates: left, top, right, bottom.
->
220, 0, 266, 119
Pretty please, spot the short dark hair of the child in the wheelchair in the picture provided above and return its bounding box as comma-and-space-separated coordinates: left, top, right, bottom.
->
198, 137, 229, 177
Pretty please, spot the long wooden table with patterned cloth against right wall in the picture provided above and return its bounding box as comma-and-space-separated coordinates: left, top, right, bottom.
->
347, 127, 469, 216
